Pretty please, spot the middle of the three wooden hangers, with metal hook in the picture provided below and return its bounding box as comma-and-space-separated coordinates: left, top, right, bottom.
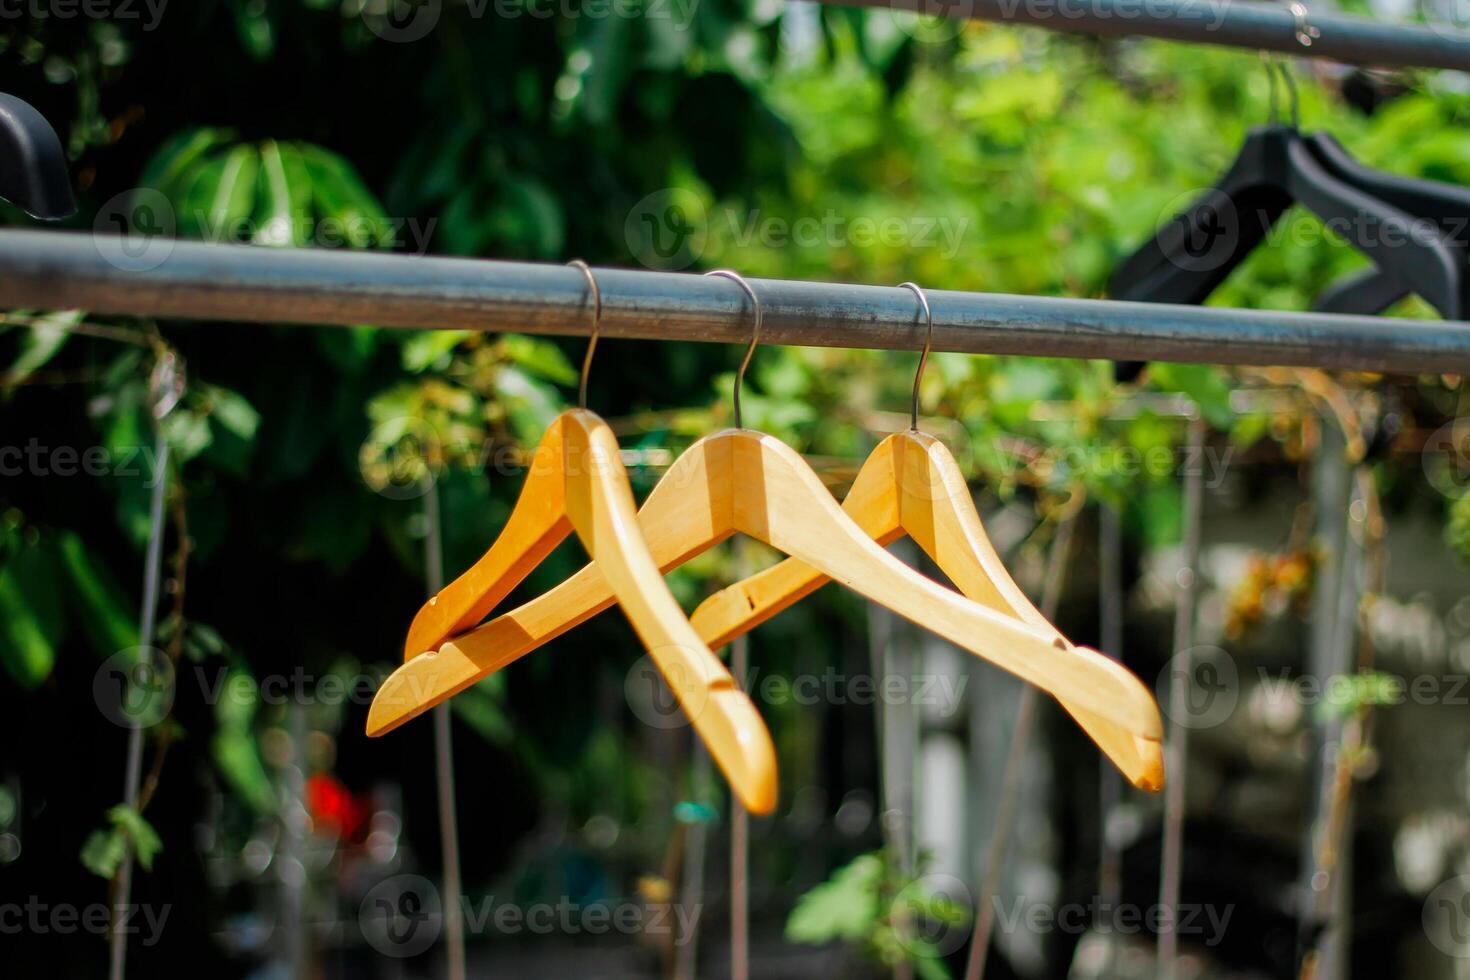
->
368, 270, 1161, 764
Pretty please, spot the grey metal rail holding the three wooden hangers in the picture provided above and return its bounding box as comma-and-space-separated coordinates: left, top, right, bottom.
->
0, 231, 1470, 373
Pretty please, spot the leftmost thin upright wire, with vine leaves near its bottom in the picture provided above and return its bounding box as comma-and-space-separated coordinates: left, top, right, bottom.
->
107, 351, 185, 980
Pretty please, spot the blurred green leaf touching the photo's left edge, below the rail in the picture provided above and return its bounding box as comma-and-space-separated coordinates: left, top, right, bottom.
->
0, 544, 66, 691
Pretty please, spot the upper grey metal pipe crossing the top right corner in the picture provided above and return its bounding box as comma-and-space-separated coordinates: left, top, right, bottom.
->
825, 0, 1470, 71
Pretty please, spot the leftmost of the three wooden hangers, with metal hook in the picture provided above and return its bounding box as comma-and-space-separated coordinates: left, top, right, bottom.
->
368, 262, 776, 814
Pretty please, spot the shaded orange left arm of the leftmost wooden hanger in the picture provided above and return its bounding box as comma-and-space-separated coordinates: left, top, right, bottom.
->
403, 413, 572, 660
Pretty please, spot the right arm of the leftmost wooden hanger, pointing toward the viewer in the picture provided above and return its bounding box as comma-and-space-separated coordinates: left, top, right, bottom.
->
564, 411, 776, 814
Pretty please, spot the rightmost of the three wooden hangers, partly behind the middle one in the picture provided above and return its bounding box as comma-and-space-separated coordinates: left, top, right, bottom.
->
689, 282, 1164, 790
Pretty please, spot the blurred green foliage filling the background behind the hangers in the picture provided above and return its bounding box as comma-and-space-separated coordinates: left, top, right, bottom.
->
0, 0, 1470, 965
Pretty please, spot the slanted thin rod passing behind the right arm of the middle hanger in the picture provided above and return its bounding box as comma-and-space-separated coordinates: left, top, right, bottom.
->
964, 514, 1076, 980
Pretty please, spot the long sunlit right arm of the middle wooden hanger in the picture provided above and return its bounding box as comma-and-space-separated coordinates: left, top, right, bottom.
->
723, 430, 1163, 739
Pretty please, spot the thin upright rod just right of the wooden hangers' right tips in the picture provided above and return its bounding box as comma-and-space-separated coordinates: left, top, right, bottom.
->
1155, 414, 1205, 980
